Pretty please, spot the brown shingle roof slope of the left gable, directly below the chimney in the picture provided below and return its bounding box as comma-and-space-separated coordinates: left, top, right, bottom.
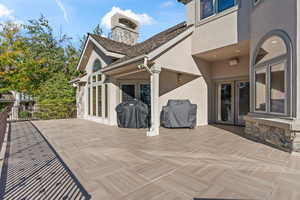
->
89, 34, 132, 55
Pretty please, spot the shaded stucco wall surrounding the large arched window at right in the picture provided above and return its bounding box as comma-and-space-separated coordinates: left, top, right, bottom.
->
250, 0, 300, 118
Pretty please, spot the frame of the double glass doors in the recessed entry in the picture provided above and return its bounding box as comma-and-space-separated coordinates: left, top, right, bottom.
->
214, 77, 250, 126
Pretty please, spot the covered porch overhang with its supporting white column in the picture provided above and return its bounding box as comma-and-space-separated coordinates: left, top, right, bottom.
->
102, 57, 199, 136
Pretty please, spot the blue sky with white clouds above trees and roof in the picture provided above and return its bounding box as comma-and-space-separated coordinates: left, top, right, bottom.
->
0, 0, 185, 45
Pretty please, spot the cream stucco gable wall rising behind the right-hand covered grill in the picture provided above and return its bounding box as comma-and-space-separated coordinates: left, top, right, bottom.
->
154, 36, 210, 126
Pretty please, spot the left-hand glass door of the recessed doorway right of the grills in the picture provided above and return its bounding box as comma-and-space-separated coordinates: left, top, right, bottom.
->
217, 82, 234, 124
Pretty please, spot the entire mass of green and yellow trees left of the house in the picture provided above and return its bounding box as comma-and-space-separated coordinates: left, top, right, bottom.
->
0, 16, 81, 119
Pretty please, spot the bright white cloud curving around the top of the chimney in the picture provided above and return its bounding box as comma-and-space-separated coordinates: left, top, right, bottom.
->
101, 6, 154, 29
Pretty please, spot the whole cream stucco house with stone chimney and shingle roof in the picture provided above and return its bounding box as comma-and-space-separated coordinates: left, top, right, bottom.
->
73, 0, 300, 151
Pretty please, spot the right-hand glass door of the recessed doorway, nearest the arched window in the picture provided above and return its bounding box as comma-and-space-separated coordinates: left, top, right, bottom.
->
236, 81, 250, 125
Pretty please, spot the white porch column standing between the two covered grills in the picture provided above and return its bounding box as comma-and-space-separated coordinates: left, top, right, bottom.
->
147, 65, 161, 136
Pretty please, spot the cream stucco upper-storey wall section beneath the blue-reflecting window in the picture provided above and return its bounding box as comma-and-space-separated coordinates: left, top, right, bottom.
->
190, 0, 252, 55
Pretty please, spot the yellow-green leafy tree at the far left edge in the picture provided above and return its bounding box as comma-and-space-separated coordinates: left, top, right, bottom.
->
0, 22, 47, 94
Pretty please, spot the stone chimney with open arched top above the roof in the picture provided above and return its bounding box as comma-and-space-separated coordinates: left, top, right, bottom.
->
111, 13, 139, 45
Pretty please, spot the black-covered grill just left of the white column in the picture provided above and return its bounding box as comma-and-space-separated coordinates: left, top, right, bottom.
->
116, 100, 148, 128
